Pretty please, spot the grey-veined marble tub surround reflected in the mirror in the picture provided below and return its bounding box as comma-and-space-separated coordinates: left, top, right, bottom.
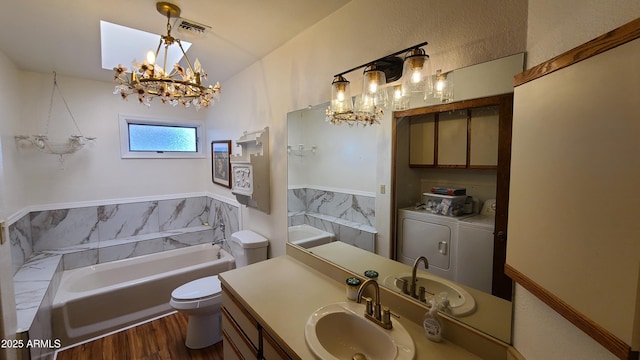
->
287, 188, 377, 252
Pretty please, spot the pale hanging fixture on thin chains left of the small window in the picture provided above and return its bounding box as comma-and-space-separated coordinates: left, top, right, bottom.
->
14, 71, 96, 166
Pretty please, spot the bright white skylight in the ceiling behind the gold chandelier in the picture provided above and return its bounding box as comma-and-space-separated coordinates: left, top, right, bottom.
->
100, 20, 191, 71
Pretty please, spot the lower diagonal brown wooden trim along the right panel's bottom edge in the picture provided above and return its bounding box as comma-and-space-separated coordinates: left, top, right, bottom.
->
504, 264, 638, 360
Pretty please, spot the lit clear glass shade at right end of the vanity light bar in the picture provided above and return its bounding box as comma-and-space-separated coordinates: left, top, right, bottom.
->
402, 48, 432, 96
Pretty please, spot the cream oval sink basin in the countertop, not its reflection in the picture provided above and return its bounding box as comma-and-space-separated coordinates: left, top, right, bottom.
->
304, 302, 416, 360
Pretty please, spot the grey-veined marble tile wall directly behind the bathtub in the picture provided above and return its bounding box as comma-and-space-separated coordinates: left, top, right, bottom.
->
9, 196, 239, 274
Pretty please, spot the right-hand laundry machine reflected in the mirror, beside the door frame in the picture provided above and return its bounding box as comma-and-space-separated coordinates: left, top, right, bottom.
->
456, 199, 496, 294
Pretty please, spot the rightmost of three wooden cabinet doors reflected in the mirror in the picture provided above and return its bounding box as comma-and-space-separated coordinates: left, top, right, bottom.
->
469, 106, 500, 168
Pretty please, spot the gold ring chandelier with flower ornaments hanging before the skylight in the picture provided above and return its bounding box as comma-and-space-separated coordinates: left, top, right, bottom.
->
113, 2, 220, 110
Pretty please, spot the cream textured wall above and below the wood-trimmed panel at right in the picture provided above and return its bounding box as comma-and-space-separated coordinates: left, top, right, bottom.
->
513, 0, 640, 360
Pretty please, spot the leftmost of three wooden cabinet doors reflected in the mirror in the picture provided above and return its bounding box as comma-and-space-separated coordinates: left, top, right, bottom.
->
409, 114, 436, 166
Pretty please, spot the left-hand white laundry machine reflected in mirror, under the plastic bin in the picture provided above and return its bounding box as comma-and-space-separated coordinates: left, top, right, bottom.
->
397, 208, 470, 281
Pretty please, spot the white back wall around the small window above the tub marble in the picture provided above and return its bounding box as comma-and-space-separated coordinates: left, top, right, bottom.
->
11, 72, 211, 210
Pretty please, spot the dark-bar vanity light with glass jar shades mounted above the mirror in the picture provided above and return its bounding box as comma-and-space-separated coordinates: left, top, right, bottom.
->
326, 41, 431, 126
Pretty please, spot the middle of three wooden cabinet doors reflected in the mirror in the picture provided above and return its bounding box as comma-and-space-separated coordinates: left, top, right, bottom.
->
437, 110, 467, 168
